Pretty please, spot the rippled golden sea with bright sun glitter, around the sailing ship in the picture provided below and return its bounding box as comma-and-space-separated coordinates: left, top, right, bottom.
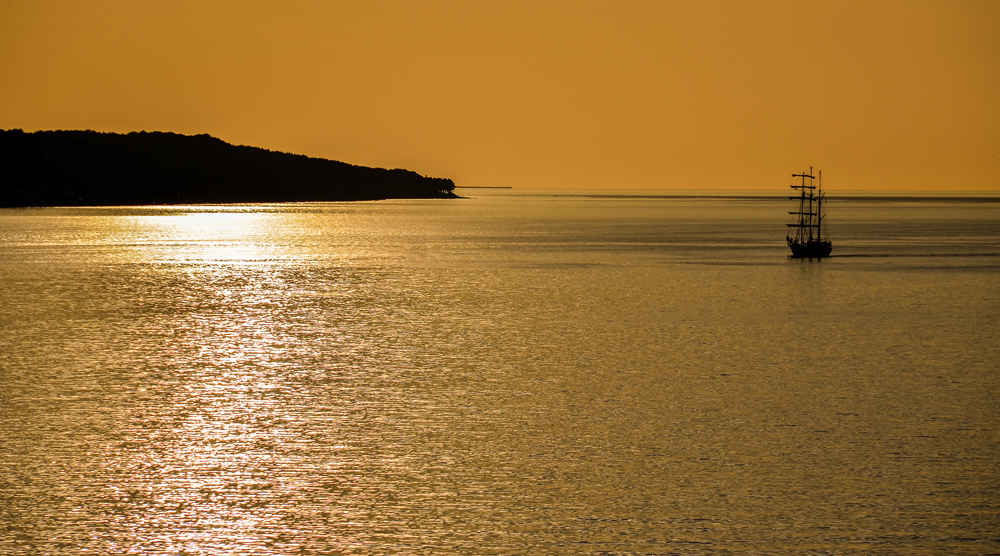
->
0, 188, 1000, 556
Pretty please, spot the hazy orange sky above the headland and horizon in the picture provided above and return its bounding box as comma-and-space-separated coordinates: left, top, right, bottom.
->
0, 0, 1000, 190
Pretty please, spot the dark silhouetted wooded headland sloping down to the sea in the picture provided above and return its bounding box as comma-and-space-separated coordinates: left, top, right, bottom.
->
0, 129, 457, 207
